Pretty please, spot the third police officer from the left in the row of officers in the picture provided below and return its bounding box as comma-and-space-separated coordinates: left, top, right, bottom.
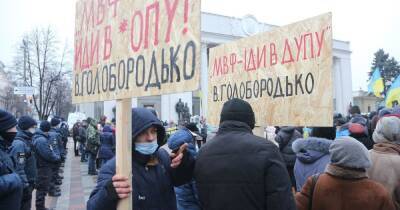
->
33, 121, 61, 210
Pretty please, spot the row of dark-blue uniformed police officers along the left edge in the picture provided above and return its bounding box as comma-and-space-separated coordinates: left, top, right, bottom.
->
0, 110, 69, 210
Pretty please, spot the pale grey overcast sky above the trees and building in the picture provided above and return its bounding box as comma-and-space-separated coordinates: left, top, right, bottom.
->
0, 0, 400, 90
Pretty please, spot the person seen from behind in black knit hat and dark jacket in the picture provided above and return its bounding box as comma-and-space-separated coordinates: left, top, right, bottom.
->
195, 99, 296, 210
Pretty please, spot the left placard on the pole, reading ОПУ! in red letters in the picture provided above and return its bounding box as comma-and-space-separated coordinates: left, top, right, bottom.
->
72, 0, 200, 103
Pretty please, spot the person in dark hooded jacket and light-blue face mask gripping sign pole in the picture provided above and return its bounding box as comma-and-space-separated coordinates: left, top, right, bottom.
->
87, 108, 194, 210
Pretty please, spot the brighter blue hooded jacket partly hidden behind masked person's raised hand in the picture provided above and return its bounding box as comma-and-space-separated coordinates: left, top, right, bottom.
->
167, 128, 201, 210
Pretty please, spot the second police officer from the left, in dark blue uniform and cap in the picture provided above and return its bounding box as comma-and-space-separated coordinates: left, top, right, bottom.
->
10, 116, 37, 210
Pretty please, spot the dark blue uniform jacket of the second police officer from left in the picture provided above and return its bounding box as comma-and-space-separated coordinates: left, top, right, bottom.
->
10, 130, 37, 186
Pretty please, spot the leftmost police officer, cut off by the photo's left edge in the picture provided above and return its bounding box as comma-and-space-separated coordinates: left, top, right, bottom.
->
0, 109, 23, 209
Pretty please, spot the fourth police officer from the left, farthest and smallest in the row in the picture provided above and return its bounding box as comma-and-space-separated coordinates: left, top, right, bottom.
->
49, 118, 64, 197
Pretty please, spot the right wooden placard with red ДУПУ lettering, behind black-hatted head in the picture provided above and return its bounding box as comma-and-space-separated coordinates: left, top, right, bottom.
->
208, 13, 333, 126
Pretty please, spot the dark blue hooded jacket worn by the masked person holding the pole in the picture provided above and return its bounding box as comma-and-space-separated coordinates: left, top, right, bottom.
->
87, 108, 194, 210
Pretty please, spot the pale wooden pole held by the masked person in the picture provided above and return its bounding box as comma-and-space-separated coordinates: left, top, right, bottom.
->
115, 98, 132, 210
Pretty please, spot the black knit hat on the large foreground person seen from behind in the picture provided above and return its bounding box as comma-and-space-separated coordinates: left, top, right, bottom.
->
220, 98, 255, 129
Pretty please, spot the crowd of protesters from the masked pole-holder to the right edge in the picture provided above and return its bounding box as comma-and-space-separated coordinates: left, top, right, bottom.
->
87, 99, 400, 210
